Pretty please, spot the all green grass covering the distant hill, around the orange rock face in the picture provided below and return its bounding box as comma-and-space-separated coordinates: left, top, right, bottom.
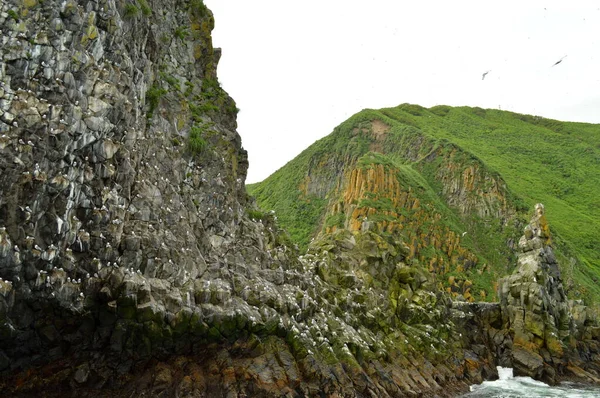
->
249, 104, 600, 301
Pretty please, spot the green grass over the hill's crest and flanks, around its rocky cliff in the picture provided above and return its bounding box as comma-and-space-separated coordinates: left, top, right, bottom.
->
249, 104, 600, 297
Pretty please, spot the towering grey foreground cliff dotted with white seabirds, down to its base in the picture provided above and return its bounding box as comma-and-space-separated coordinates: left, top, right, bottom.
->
0, 0, 496, 397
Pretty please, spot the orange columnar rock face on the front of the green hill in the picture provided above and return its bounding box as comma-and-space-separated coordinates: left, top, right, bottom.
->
325, 164, 477, 300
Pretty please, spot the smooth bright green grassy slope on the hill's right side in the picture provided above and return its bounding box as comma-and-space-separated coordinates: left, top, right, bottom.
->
382, 105, 600, 296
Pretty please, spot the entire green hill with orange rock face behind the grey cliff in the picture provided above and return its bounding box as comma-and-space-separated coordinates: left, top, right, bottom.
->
248, 104, 600, 301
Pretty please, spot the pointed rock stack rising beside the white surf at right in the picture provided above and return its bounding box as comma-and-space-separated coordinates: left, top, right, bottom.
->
499, 203, 600, 383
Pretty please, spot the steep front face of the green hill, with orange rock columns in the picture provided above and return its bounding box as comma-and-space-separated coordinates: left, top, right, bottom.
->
252, 116, 520, 301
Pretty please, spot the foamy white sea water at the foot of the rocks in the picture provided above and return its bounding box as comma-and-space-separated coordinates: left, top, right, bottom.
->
462, 366, 600, 398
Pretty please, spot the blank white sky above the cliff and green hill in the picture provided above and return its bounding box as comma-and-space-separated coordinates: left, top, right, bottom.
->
204, 0, 600, 183
